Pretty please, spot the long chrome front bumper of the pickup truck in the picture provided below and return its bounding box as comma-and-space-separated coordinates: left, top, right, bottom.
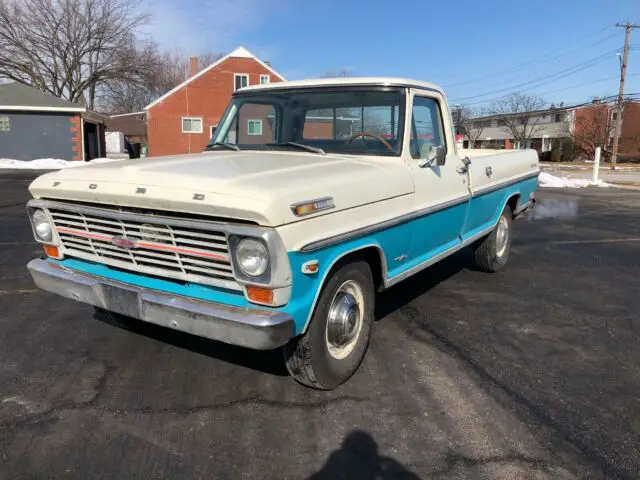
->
27, 258, 294, 350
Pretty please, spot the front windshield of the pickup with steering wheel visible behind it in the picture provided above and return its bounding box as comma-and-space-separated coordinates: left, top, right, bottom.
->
207, 88, 404, 155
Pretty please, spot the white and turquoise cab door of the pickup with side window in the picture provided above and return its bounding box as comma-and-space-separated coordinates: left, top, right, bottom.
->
408, 91, 469, 265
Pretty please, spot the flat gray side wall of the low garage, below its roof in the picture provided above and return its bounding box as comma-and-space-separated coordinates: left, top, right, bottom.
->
0, 110, 74, 160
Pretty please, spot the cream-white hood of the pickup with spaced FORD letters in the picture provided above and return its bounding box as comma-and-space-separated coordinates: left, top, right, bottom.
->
29, 151, 413, 226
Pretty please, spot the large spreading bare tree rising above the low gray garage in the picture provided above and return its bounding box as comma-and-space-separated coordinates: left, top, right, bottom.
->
0, 0, 157, 109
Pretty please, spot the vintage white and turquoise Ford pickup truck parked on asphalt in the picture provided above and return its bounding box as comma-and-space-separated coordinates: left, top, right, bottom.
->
28, 78, 539, 389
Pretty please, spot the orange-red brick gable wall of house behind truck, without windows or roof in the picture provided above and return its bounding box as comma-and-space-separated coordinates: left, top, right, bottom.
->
147, 57, 282, 156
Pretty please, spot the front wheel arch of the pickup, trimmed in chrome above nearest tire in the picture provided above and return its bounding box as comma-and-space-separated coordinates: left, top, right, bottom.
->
300, 243, 387, 334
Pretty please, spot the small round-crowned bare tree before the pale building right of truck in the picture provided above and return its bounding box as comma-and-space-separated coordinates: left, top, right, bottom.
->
490, 92, 546, 145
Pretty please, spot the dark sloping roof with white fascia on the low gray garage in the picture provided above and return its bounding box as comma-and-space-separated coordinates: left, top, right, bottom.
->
0, 82, 86, 112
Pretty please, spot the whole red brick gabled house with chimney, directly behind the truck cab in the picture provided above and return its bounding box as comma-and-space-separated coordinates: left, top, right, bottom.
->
145, 47, 285, 156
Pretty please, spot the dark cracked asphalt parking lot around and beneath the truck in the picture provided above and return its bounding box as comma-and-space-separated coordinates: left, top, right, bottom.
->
0, 172, 640, 479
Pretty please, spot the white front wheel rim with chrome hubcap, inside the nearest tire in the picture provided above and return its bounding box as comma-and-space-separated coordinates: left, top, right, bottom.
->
325, 280, 364, 359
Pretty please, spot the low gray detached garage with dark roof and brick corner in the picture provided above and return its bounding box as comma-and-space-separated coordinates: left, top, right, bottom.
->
0, 82, 105, 161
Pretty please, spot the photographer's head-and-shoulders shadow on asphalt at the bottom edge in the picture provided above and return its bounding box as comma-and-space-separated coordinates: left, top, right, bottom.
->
308, 430, 420, 480
